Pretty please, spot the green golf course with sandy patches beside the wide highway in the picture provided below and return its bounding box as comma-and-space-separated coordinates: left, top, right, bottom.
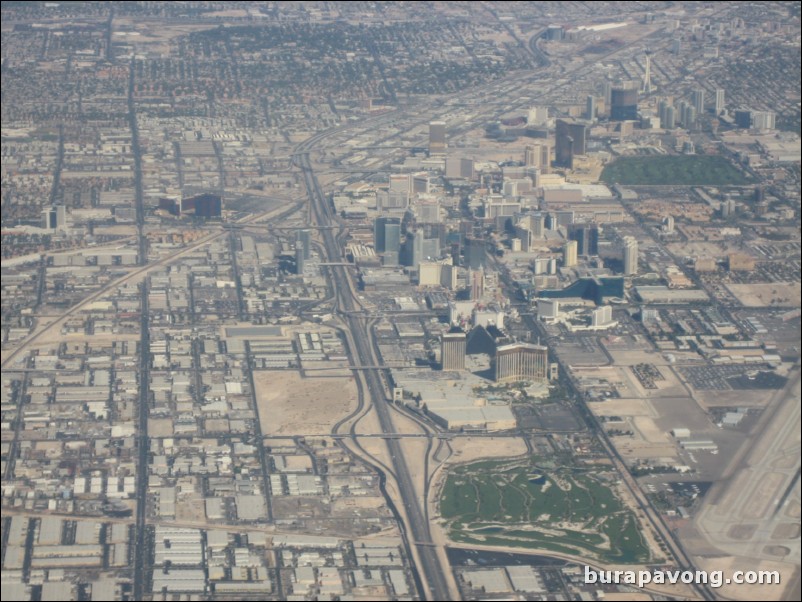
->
440, 460, 649, 563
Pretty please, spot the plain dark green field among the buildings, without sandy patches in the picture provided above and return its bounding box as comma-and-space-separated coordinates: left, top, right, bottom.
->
601, 155, 749, 186
